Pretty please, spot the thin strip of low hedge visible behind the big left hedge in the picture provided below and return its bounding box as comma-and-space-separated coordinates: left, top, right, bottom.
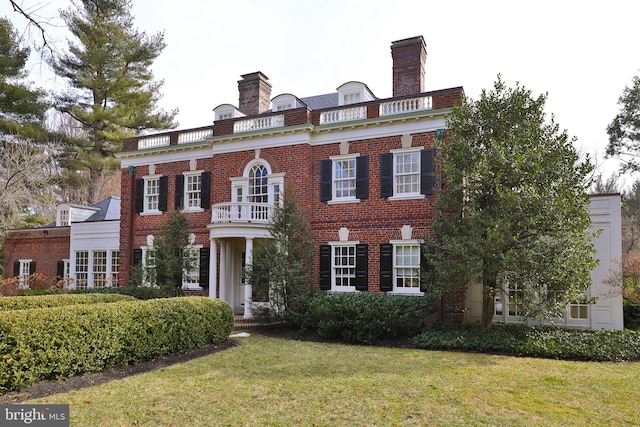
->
0, 294, 135, 311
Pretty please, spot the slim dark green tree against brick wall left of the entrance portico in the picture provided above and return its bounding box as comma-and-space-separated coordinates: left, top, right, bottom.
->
152, 211, 197, 296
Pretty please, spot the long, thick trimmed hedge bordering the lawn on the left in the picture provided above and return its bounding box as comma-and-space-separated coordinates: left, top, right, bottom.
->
0, 297, 234, 393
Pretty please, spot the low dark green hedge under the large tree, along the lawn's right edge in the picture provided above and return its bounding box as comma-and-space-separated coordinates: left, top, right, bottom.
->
413, 324, 640, 362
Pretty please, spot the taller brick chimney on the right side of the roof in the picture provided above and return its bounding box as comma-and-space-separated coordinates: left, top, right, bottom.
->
391, 36, 427, 97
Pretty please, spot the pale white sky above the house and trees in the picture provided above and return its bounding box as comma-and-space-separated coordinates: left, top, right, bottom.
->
5, 0, 640, 185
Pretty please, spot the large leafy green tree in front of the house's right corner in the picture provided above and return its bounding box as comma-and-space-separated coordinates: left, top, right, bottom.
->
426, 76, 595, 330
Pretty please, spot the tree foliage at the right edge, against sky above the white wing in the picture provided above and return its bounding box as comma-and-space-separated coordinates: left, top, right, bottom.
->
607, 76, 640, 172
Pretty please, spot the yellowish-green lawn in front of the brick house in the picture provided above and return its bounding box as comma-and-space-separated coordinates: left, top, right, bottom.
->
31, 335, 640, 427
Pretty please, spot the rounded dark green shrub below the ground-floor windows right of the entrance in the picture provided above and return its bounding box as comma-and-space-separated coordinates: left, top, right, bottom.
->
296, 292, 434, 344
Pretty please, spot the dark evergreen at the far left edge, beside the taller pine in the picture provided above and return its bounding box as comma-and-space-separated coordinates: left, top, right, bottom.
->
0, 18, 48, 142
